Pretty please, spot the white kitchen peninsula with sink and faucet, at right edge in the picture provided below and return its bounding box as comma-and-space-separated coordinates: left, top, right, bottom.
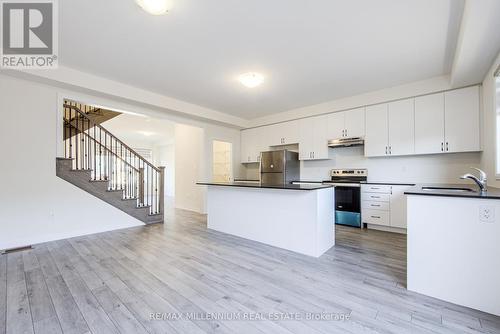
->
405, 184, 500, 316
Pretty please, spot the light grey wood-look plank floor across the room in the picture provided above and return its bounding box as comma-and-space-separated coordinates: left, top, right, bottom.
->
0, 210, 500, 334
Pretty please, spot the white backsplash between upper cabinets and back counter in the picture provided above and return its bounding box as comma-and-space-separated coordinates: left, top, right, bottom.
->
244, 146, 481, 183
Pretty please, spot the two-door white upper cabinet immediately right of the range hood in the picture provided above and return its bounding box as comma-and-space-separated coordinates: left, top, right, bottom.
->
365, 99, 415, 157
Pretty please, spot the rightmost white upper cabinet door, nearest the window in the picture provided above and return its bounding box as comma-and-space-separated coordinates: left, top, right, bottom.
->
444, 86, 481, 152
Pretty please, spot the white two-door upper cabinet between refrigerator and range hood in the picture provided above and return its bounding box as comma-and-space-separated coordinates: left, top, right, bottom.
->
299, 116, 328, 160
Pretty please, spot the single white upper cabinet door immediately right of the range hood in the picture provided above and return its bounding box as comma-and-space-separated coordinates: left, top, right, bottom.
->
365, 103, 389, 157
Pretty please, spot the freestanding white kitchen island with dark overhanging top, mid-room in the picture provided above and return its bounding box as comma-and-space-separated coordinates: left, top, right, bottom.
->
198, 182, 335, 257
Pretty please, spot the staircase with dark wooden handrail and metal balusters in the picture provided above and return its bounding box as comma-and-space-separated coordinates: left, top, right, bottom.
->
56, 101, 164, 224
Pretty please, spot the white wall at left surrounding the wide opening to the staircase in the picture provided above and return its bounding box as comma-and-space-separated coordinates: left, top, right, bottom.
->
0, 74, 240, 249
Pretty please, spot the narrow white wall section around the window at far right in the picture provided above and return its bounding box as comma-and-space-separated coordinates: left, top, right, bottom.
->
481, 54, 500, 187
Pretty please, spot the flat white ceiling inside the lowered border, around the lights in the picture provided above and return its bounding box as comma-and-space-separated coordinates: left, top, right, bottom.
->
59, 0, 463, 119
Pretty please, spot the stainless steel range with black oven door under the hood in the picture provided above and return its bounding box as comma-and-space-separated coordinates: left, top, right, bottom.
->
323, 169, 368, 227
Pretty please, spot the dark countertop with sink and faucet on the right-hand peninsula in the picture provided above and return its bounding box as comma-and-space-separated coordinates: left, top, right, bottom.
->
405, 183, 500, 200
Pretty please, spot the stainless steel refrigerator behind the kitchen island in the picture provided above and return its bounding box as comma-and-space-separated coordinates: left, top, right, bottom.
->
260, 150, 300, 185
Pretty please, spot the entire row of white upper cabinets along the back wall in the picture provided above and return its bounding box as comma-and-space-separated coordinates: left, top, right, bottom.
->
241, 86, 481, 163
